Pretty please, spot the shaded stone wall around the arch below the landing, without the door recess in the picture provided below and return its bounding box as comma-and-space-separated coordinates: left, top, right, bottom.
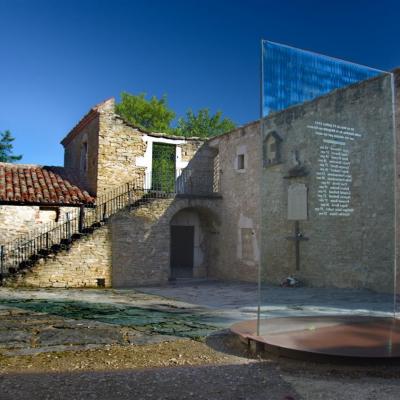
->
111, 198, 221, 287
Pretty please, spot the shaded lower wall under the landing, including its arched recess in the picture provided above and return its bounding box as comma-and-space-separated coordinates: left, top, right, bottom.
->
110, 197, 220, 288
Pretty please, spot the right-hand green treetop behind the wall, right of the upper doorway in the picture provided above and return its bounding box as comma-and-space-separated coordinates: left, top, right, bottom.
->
175, 108, 236, 138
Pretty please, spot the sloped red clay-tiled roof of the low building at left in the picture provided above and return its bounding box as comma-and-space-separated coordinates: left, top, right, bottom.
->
0, 163, 95, 206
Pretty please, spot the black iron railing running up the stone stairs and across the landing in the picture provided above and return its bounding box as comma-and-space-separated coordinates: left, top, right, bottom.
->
0, 170, 216, 282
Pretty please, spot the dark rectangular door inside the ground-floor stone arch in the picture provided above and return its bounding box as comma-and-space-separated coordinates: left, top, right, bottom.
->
171, 225, 194, 278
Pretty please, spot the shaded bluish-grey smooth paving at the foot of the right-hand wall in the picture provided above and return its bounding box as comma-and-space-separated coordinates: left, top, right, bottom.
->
137, 281, 393, 316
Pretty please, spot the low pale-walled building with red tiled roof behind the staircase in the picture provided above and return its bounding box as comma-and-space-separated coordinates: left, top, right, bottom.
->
0, 163, 95, 244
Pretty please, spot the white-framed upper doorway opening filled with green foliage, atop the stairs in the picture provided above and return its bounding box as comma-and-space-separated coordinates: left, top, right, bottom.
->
151, 143, 176, 193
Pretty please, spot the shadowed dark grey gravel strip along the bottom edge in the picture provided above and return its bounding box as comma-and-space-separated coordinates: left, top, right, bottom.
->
0, 362, 400, 400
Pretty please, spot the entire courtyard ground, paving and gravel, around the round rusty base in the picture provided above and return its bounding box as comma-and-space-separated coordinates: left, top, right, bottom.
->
0, 281, 400, 400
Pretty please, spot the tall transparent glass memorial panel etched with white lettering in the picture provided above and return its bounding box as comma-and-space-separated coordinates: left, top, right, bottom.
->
257, 41, 397, 354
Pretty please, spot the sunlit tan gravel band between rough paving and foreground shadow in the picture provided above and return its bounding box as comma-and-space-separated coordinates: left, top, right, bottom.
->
0, 339, 241, 376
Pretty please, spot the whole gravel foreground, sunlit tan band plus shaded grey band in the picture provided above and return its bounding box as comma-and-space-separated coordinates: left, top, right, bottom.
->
0, 334, 400, 400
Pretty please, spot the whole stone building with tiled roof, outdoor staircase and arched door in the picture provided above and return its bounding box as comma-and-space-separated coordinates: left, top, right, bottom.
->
0, 99, 221, 287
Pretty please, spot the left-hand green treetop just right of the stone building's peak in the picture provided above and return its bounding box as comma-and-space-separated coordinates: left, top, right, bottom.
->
115, 92, 175, 133
